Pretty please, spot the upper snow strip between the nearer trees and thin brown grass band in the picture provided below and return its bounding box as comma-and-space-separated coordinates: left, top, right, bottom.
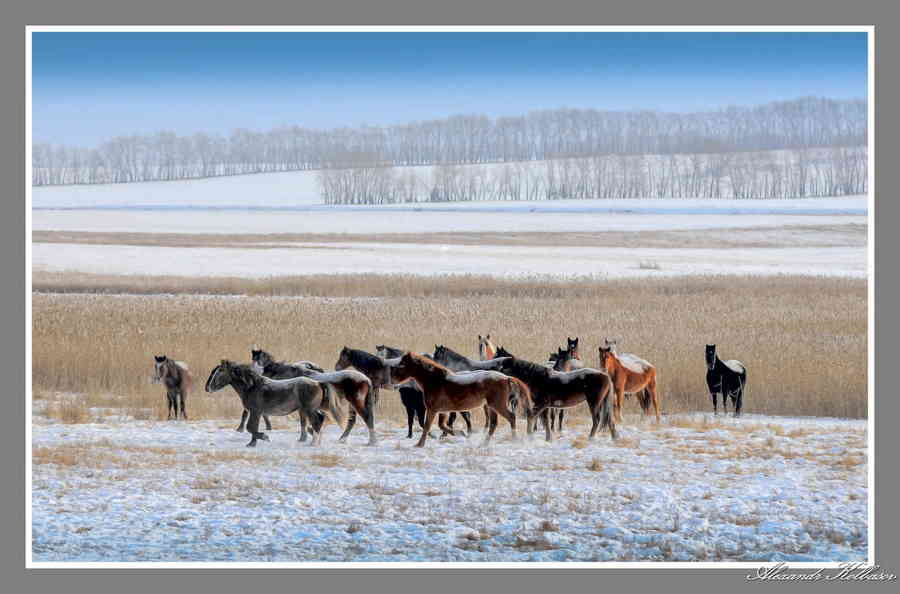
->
32, 194, 868, 234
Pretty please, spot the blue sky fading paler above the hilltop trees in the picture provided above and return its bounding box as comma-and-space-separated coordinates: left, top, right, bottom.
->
32, 32, 867, 146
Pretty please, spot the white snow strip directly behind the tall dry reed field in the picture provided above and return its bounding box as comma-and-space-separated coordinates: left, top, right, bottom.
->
32, 243, 866, 278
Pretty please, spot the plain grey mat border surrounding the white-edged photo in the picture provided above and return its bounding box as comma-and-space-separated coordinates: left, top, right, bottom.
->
0, 0, 900, 594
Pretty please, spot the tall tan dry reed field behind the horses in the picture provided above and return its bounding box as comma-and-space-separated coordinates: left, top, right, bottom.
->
32, 273, 867, 426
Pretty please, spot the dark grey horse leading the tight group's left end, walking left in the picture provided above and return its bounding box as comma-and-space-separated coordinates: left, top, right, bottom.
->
206, 359, 343, 447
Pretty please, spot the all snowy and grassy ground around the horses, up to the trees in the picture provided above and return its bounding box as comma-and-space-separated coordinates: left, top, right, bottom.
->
31, 174, 869, 563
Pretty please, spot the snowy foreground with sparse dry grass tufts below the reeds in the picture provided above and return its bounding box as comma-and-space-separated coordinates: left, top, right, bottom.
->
32, 414, 868, 562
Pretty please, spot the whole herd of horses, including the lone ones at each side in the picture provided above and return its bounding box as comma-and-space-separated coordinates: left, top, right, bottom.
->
153, 334, 747, 447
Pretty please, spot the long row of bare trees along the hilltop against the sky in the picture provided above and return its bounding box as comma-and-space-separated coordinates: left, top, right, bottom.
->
32, 97, 867, 194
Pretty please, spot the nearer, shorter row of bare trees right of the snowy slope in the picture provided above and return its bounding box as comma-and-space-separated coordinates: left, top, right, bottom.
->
317, 147, 868, 205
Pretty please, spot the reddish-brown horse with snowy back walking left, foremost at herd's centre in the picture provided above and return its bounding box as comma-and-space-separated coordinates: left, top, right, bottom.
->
391, 353, 533, 448
